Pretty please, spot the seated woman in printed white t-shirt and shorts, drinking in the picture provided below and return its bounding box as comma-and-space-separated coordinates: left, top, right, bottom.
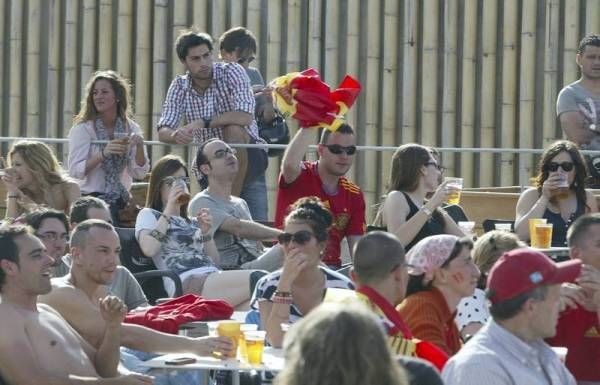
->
135, 155, 253, 309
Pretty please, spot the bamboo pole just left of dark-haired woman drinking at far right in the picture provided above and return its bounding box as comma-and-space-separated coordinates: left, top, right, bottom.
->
519, 1, 537, 183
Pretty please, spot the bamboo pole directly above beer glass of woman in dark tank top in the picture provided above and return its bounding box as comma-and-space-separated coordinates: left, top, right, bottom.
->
440, 1, 458, 175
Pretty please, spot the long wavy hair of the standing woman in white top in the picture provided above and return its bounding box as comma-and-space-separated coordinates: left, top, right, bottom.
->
73, 70, 132, 124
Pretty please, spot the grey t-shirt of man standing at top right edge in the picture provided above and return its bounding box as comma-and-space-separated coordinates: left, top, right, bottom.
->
556, 80, 600, 150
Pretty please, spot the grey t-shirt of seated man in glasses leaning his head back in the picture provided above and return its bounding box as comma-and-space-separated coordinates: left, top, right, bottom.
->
188, 190, 262, 268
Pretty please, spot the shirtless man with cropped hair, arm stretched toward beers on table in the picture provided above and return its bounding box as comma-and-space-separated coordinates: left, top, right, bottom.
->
40, 219, 233, 356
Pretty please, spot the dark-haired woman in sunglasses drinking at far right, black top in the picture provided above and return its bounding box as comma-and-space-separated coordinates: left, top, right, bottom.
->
515, 140, 598, 247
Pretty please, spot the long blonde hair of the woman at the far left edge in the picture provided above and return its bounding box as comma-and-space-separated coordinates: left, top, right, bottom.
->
8, 140, 69, 189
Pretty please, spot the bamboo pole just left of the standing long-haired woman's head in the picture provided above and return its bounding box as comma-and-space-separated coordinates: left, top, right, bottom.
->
63, 0, 79, 148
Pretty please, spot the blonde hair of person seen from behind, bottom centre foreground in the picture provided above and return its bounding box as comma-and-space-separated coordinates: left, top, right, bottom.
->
274, 303, 408, 385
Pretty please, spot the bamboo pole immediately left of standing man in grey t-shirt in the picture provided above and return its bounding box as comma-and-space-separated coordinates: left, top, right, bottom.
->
542, 0, 560, 147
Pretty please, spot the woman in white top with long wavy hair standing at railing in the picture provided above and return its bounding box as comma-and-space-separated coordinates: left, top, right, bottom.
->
68, 71, 150, 226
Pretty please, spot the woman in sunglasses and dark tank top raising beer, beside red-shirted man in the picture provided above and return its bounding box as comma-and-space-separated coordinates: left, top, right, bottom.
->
375, 143, 465, 251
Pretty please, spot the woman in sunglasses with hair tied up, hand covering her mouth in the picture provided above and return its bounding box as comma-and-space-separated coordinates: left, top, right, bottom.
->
251, 197, 354, 347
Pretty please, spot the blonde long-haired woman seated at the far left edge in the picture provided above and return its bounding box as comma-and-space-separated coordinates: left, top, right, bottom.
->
2, 140, 81, 218
